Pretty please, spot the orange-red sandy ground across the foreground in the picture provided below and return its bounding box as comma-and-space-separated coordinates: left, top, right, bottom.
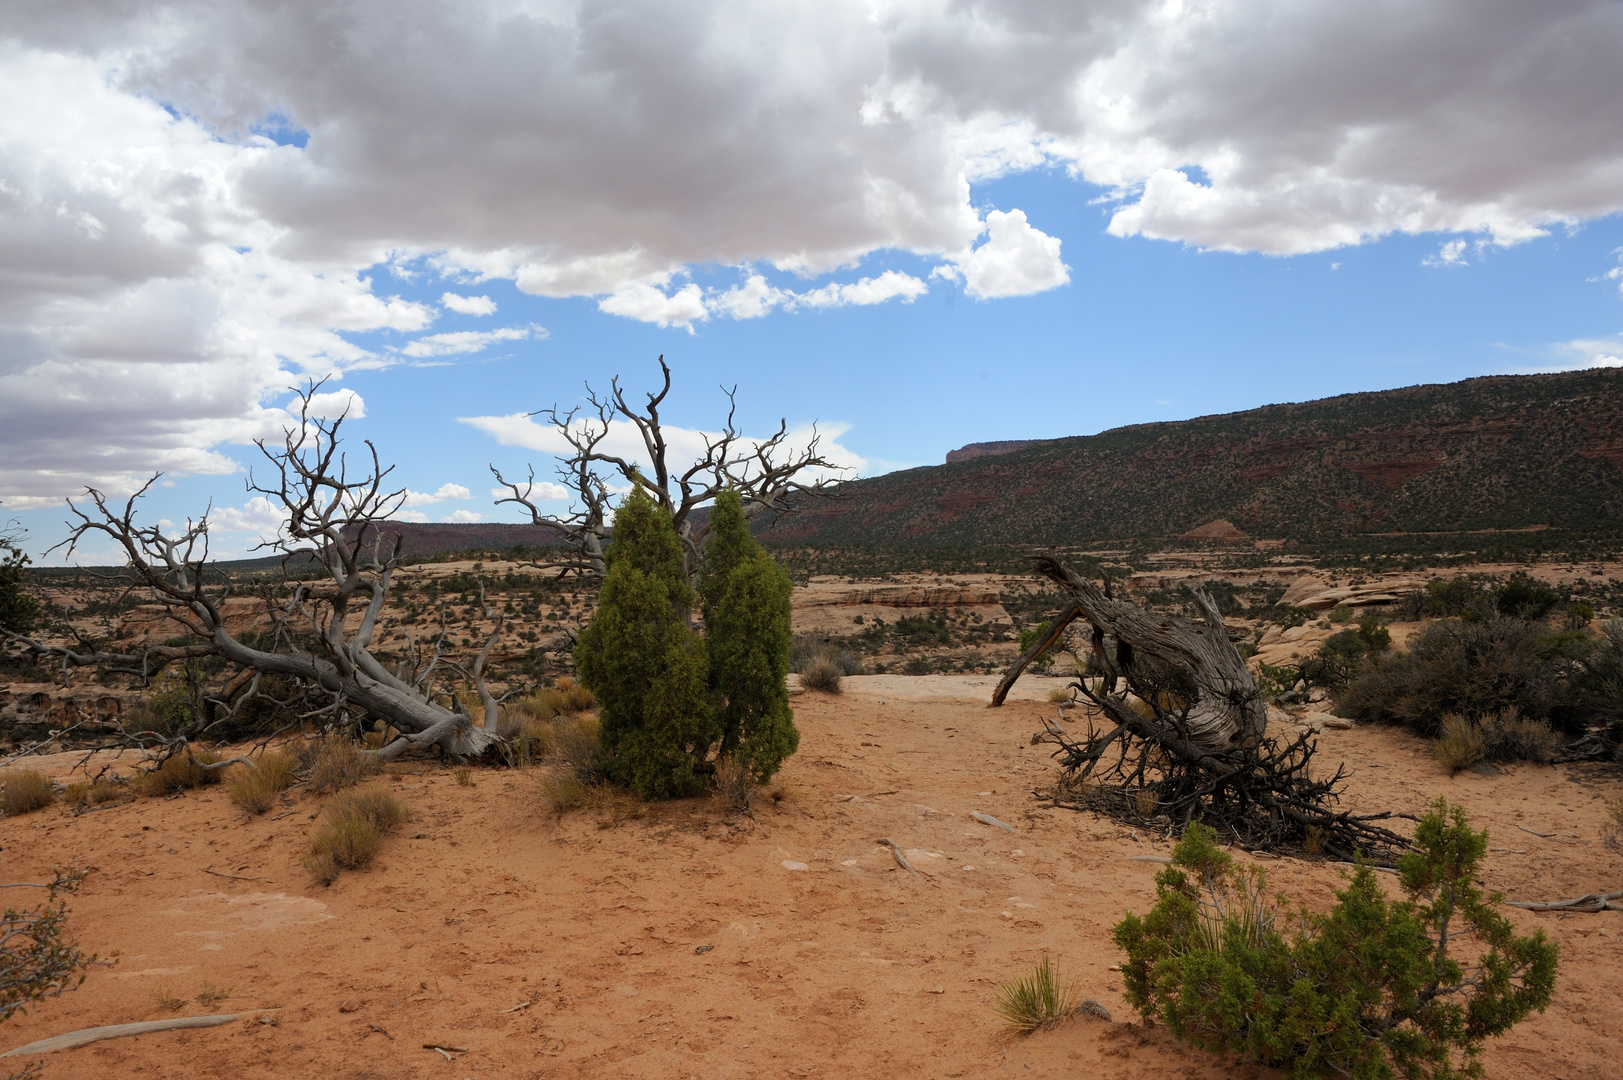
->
0, 677, 1623, 1080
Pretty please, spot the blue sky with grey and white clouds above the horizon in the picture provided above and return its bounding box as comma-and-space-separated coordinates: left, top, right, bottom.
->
0, 0, 1623, 564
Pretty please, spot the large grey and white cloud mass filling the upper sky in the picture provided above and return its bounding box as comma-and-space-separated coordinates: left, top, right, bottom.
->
0, 0, 1623, 508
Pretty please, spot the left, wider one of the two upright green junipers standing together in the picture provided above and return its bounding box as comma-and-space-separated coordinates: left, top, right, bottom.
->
575, 487, 719, 801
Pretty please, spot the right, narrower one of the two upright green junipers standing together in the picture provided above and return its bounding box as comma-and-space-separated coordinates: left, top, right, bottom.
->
700, 490, 800, 784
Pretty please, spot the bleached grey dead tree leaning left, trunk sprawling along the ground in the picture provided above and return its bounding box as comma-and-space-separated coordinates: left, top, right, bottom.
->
6, 383, 502, 765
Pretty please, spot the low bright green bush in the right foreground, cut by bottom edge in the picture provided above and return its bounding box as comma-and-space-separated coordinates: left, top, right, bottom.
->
1113, 799, 1558, 1080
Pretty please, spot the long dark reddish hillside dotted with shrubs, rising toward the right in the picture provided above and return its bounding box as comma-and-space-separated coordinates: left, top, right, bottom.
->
763, 370, 1623, 546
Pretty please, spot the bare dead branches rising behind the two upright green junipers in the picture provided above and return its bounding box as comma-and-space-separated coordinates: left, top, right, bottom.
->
490, 356, 841, 583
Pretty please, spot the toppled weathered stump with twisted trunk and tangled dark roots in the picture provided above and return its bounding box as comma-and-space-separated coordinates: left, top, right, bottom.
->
992, 555, 1404, 862
